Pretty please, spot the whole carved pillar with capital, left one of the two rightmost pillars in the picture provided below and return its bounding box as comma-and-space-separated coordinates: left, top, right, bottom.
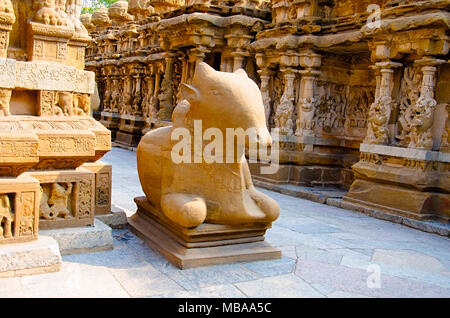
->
364, 60, 402, 145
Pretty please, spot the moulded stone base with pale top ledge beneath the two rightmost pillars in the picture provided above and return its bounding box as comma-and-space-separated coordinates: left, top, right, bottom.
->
343, 144, 450, 223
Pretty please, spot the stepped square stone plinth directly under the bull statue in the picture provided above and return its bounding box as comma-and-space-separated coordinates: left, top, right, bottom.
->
128, 197, 281, 269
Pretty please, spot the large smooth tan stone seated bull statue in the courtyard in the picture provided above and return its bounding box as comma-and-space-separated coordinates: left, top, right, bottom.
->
137, 63, 280, 227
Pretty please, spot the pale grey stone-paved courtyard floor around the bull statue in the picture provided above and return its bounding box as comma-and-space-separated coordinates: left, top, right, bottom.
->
0, 148, 450, 298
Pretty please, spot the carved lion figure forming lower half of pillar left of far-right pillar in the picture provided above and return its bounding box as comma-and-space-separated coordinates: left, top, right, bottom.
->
364, 96, 392, 144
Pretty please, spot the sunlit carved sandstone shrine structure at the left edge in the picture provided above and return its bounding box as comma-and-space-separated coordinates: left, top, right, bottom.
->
0, 0, 116, 275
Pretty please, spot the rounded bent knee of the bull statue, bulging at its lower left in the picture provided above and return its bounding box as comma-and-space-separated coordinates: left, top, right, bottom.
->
161, 193, 207, 228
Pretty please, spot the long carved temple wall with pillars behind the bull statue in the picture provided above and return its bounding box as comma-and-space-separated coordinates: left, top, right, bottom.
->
83, 0, 450, 221
